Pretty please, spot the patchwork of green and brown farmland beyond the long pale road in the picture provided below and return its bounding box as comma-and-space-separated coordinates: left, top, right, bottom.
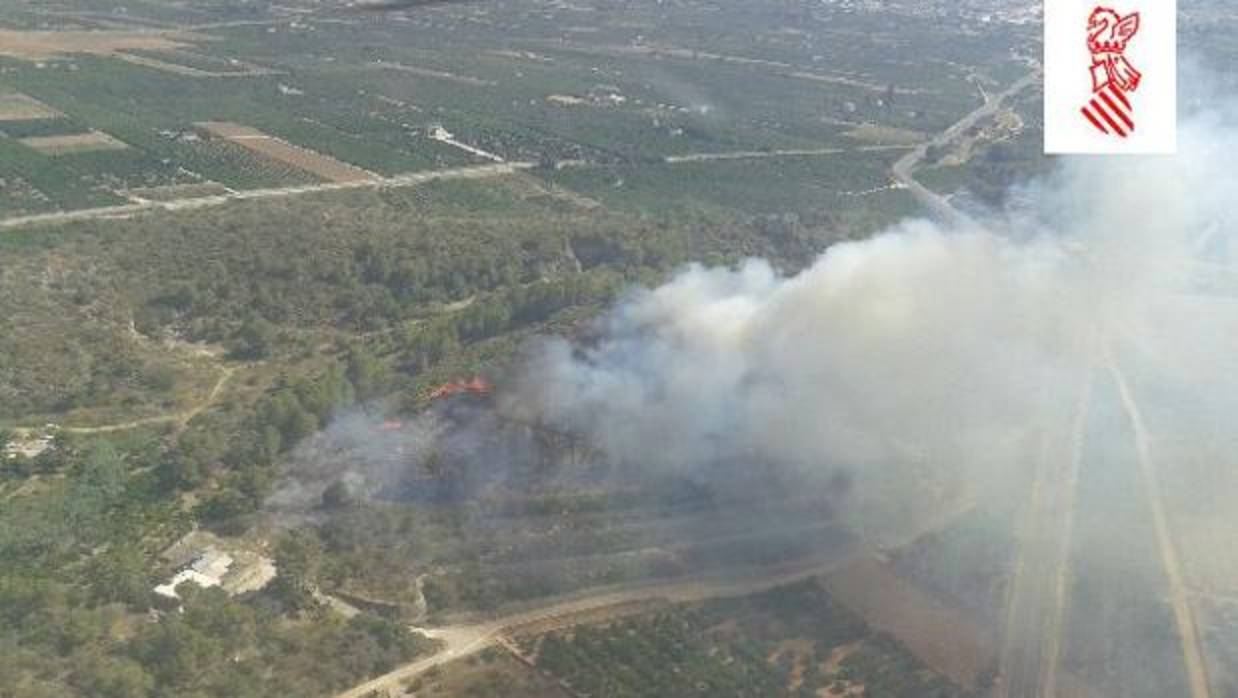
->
0, 1, 1032, 217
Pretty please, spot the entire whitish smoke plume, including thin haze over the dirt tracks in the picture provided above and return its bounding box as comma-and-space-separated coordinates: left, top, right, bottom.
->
256, 65, 1238, 696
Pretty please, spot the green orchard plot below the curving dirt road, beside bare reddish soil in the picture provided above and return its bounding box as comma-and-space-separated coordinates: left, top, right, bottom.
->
497, 580, 968, 698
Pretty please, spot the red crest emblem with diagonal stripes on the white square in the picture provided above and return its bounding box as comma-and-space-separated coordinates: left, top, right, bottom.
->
1081, 6, 1143, 139
